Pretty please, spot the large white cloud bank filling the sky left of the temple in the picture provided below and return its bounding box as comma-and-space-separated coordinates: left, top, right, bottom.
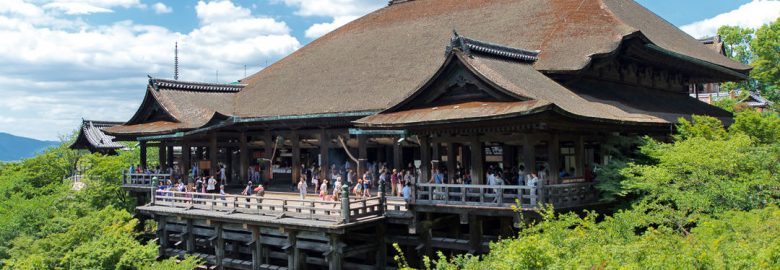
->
0, 0, 301, 139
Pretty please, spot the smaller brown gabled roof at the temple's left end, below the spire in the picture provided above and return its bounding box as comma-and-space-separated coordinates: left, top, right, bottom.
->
106, 77, 245, 137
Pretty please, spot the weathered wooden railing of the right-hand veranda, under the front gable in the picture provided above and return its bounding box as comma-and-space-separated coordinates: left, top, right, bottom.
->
414, 183, 598, 208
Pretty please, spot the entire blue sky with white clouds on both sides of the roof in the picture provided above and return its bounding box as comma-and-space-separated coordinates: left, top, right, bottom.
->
0, 0, 780, 140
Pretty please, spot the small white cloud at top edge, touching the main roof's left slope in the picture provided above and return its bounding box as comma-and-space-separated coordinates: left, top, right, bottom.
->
284, 0, 387, 38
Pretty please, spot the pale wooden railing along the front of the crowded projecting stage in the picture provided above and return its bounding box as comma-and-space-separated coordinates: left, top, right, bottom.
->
152, 190, 383, 223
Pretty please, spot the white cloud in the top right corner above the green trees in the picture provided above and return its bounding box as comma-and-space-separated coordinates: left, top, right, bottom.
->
680, 0, 780, 38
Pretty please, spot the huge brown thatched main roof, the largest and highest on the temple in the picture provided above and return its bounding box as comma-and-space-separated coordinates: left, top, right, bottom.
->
234, 0, 750, 120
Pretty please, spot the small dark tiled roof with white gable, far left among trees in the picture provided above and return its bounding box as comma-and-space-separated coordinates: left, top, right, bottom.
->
70, 120, 125, 154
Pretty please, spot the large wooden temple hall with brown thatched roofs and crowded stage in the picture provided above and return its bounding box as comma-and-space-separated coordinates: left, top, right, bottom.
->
105, 0, 750, 269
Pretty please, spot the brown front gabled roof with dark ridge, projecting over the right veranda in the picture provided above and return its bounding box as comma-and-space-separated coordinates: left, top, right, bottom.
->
355, 35, 730, 128
